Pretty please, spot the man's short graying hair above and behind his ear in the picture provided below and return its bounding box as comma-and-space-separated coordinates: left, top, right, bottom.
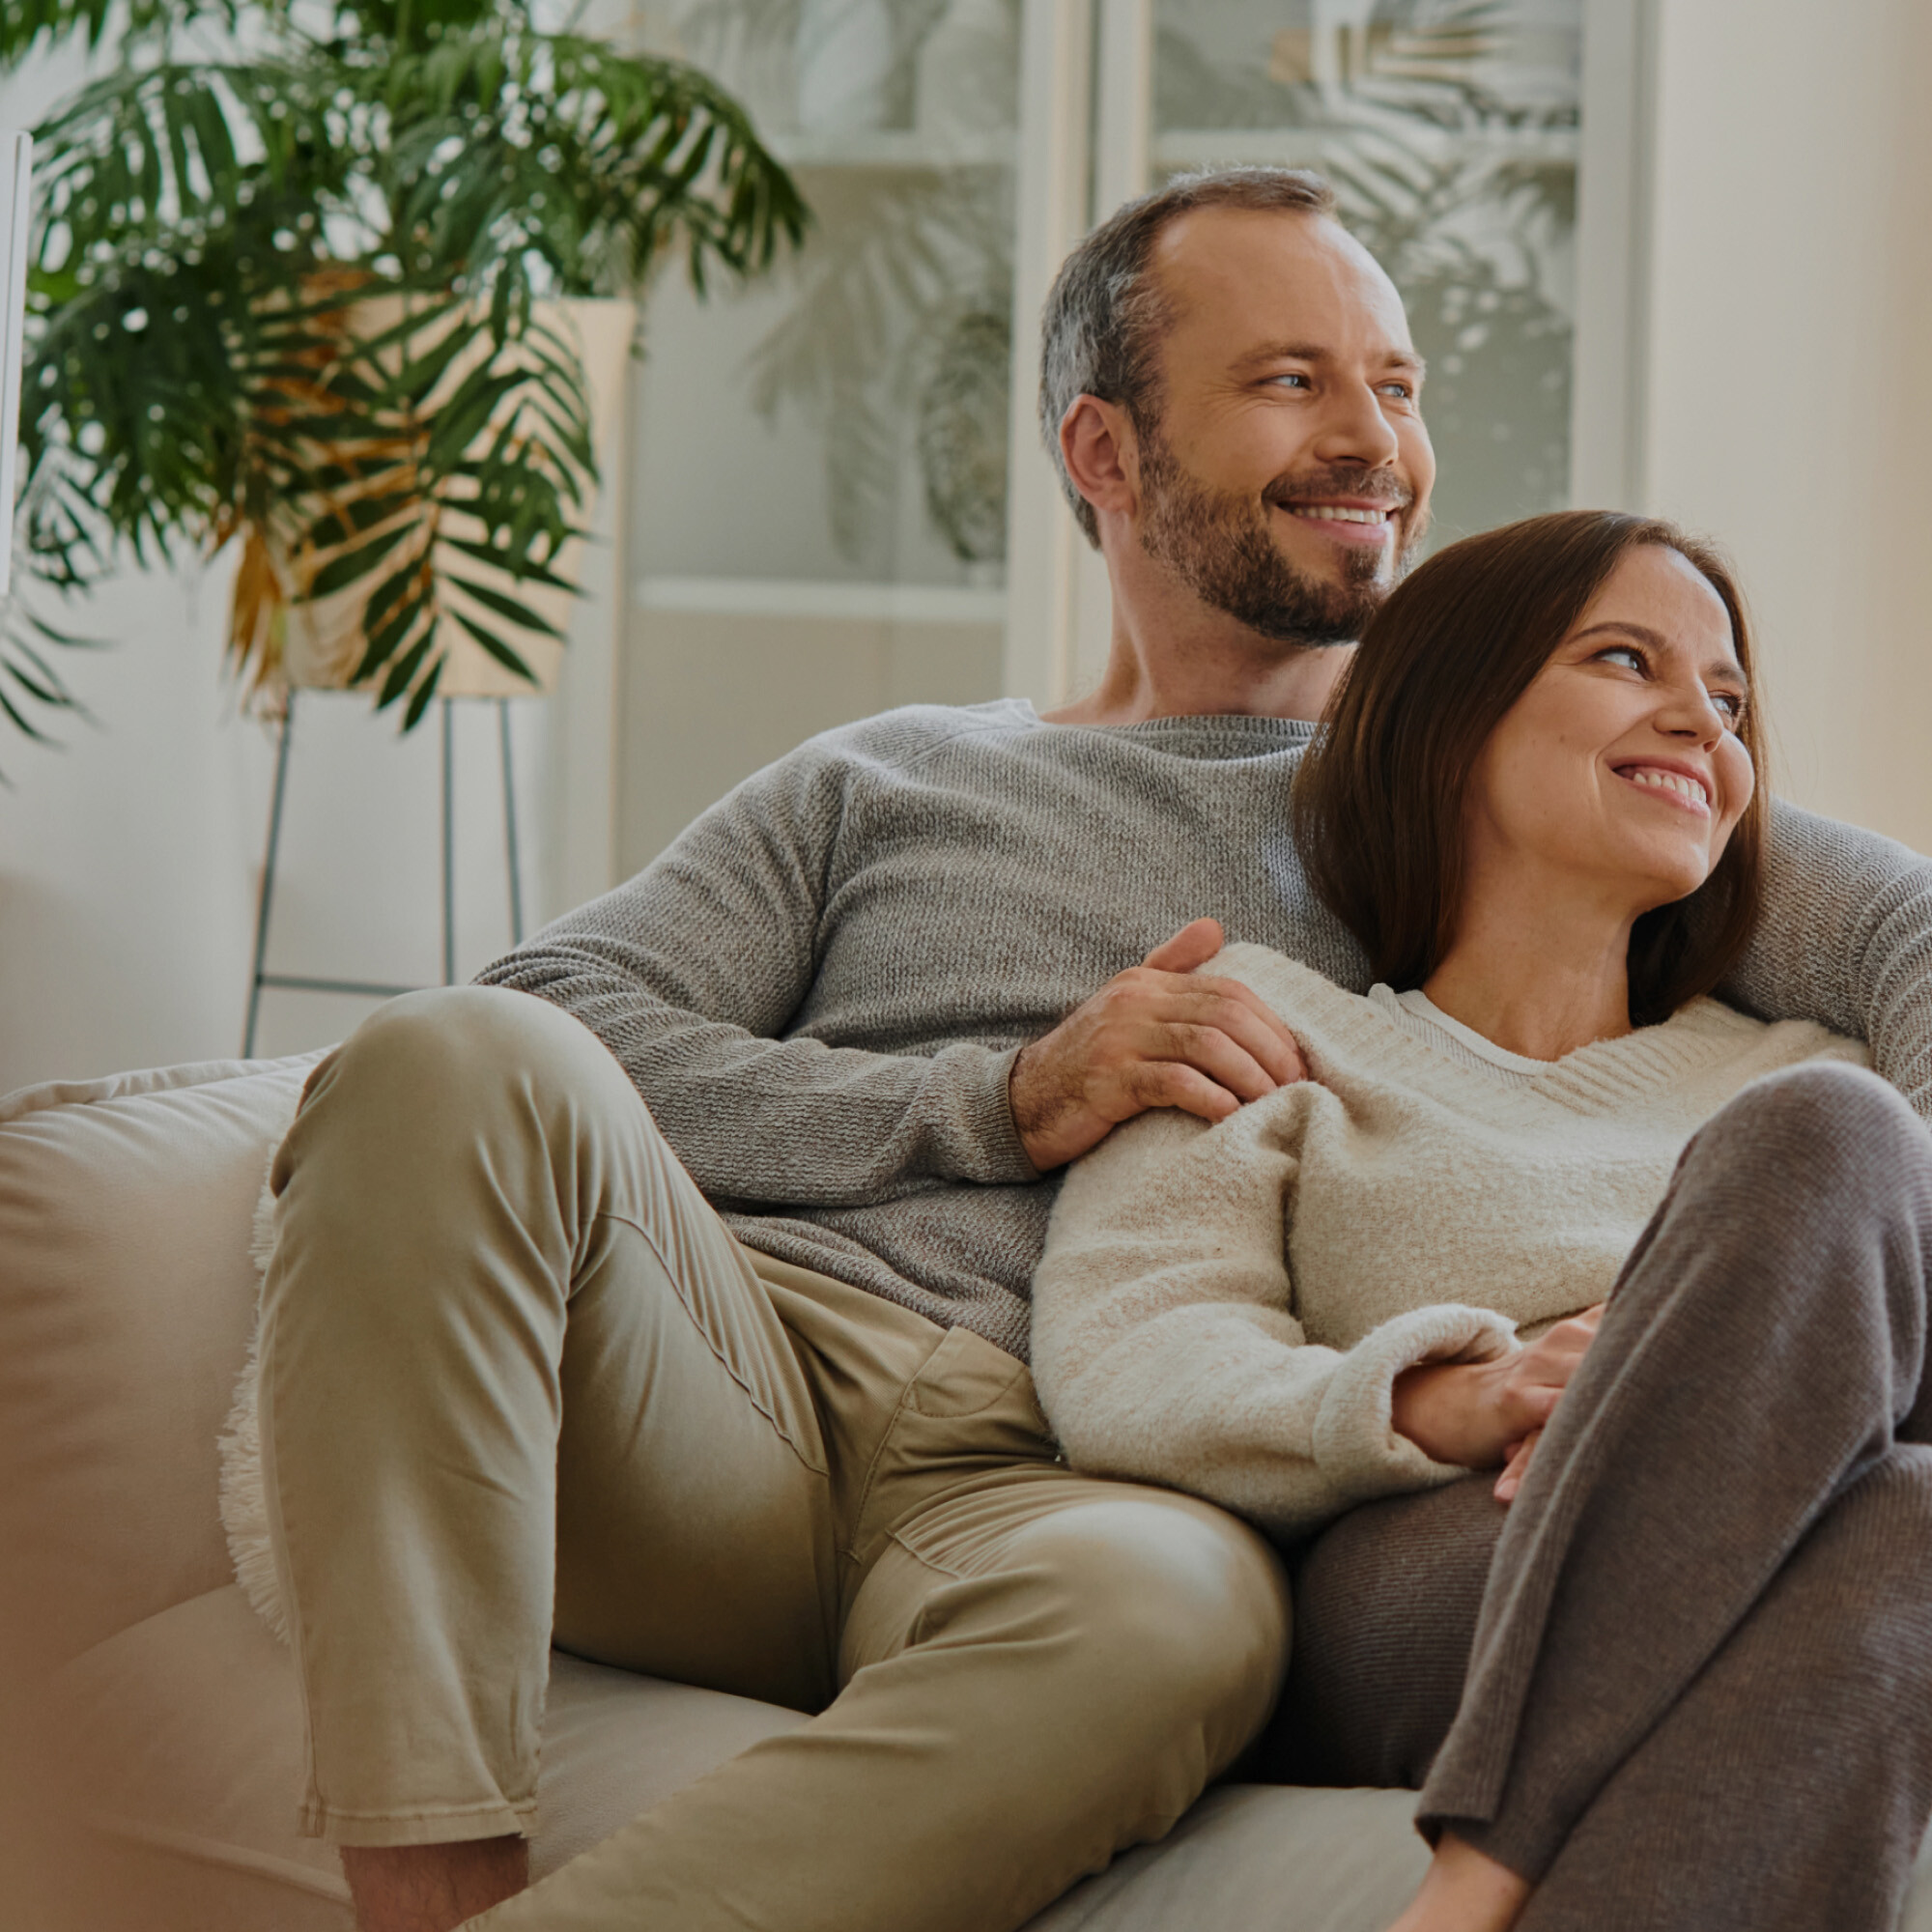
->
1039, 168, 1335, 549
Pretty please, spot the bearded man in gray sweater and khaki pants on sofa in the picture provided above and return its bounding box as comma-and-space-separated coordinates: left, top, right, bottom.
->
263, 170, 1932, 1932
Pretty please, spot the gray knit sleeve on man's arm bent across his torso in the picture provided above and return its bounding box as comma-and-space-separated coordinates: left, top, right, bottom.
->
479, 744, 1036, 1206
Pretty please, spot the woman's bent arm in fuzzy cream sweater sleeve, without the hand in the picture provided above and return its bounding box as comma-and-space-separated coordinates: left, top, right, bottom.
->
1034, 1088, 1515, 1532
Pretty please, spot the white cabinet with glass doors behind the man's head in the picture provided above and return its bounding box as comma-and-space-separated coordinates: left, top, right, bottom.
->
616, 0, 1646, 869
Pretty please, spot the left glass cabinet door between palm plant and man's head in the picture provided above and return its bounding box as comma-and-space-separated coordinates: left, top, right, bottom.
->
616, 0, 1020, 869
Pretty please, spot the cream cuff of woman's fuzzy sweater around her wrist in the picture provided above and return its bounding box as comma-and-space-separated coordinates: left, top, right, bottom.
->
1314, 1302, 1517, 1501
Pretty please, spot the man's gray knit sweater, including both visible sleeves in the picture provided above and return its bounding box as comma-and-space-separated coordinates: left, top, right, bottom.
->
481, 699, 1932, 1358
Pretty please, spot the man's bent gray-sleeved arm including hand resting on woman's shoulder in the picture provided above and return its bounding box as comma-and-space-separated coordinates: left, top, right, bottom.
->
479, 742, 1300, 1208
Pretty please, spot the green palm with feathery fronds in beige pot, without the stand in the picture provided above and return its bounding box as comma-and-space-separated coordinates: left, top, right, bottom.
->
0, 0, 808, 732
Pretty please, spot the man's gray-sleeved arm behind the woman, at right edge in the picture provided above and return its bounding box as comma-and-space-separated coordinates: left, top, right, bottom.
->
1719, 802, 1932, 1121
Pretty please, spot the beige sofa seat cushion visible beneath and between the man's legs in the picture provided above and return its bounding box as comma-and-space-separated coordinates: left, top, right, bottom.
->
60, 1584, 1453, 1932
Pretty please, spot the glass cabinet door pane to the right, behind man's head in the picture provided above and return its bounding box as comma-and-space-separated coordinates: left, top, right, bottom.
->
1151, 0, 1582, 543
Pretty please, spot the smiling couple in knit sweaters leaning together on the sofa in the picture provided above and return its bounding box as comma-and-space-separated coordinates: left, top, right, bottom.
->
259, 170, 1932, 1932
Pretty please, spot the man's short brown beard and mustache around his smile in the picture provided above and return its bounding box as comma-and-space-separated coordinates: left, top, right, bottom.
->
1140, 425, 1428, 643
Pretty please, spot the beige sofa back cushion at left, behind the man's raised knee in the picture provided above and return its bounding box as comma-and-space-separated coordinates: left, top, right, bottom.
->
0, 1055, 315, 1658
